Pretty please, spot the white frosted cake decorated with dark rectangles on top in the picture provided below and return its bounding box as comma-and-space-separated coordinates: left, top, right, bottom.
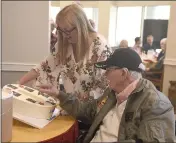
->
2, 84, 56, 119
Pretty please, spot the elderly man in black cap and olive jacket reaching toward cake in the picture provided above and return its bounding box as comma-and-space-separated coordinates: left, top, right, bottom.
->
40, 48, 175, 143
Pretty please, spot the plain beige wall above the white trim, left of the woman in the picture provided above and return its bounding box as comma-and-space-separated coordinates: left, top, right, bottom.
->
2, 1, 50, 69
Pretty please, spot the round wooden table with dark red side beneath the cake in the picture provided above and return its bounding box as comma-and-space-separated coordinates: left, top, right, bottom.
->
11, 116, 78, 143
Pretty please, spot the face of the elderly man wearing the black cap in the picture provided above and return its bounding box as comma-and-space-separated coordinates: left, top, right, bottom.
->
105, 67, 123, 90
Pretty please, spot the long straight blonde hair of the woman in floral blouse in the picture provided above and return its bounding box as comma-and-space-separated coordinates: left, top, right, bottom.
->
56, 4, 95, 64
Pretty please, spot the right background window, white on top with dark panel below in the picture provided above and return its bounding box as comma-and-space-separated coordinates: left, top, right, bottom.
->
142, 5, 170, 48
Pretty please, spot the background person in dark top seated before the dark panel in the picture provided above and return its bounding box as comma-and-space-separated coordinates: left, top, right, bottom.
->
143, 35, 156, 54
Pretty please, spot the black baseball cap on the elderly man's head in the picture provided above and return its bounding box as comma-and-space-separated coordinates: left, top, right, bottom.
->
95, 48, 145, 72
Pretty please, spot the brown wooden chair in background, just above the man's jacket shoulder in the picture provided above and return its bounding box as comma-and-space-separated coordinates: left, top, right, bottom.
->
144, 69, 164, 92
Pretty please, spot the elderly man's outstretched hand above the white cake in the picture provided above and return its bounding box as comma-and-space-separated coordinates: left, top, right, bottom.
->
38, 85, 59, 97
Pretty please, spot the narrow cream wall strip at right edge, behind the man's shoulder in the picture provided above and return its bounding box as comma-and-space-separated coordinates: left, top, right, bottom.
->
163, 1, 176, 94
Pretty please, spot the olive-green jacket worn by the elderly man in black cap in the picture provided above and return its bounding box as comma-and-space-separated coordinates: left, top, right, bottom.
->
58, 79, 175, 143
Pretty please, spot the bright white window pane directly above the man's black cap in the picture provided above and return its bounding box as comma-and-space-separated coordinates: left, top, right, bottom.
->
116, 7, 142, 47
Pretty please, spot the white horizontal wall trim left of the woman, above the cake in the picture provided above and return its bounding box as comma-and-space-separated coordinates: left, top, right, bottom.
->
2, 62, 37, 71
